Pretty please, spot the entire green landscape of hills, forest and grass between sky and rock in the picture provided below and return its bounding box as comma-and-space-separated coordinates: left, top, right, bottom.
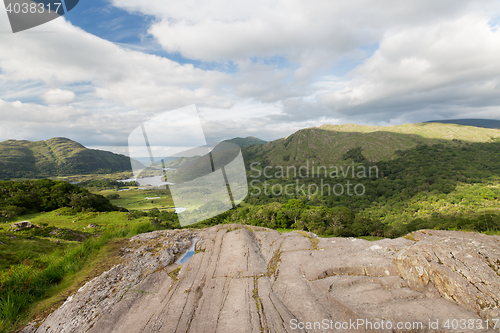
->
0, 123, 500, 332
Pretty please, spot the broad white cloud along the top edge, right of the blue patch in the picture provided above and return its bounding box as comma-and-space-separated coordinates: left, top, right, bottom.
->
113, 0, 494, 62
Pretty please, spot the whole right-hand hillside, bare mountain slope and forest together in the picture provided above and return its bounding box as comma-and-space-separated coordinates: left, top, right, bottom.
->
243, 124, 500, 228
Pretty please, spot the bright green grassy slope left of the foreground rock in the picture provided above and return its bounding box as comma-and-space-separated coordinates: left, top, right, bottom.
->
0, 208, 161, 332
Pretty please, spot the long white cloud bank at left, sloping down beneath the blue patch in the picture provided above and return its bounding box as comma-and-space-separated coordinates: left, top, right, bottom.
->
0, 13, 231, 111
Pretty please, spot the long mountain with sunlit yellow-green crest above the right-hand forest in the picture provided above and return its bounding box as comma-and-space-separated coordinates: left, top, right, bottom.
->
243, 123, 500, 166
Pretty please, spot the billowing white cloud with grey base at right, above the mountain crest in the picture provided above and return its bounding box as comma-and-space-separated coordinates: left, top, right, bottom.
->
320, 15, 500, 121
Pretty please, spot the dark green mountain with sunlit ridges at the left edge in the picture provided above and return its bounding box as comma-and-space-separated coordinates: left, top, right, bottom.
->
0, 138, 131, 179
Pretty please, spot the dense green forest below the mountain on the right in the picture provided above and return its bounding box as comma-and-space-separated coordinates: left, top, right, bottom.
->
193, 142, 500, 237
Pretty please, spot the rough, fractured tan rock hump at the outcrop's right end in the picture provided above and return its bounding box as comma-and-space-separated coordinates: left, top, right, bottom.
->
395, 230, 500, 320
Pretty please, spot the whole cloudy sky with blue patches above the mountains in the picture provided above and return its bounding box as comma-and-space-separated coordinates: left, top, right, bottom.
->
0, 0, 500, 154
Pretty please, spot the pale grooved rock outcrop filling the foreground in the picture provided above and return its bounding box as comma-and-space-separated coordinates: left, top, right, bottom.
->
24, 225, 500, 333
